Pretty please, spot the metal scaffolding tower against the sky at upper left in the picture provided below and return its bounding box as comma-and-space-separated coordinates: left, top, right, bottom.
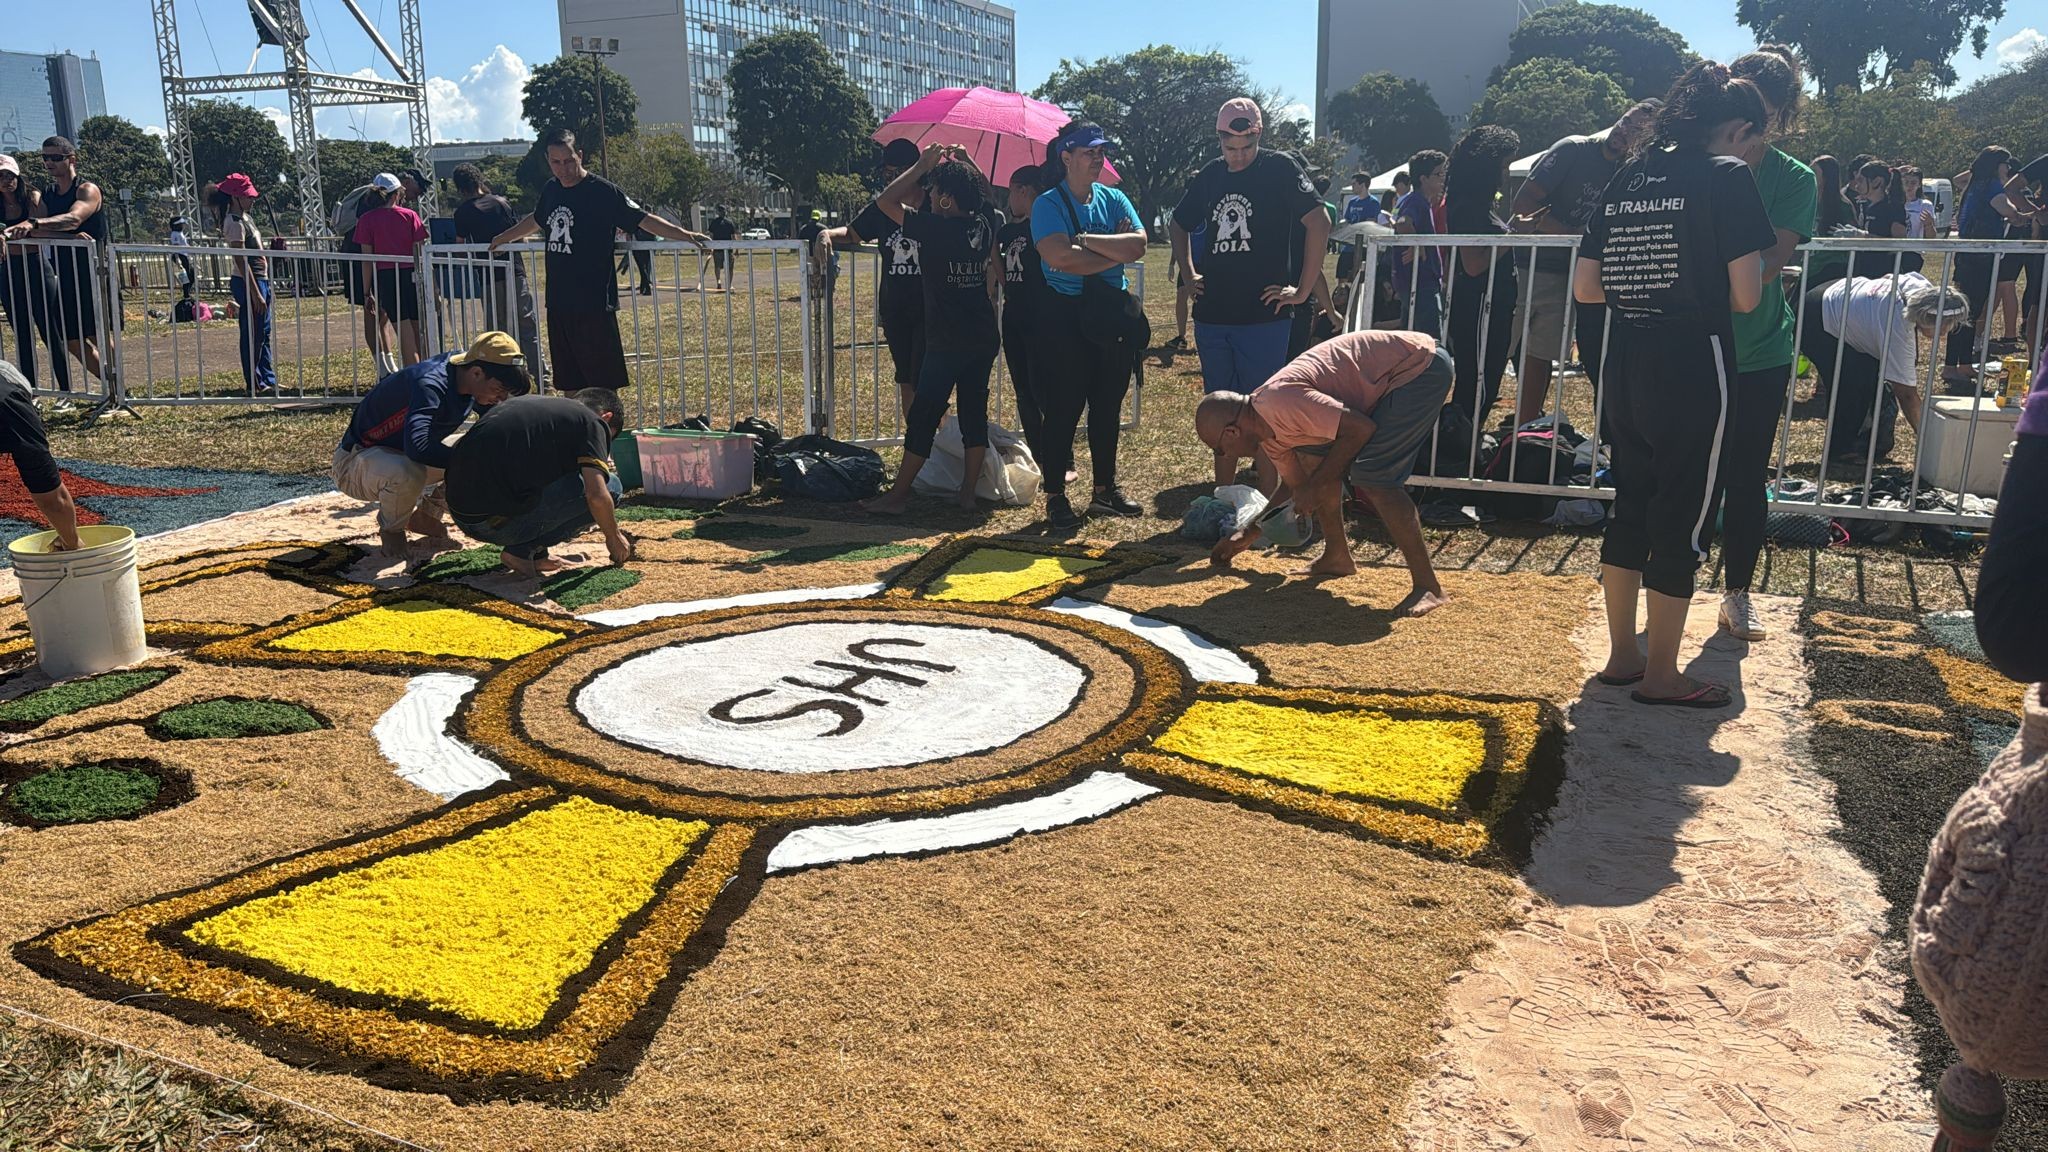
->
150, 0, 436, 236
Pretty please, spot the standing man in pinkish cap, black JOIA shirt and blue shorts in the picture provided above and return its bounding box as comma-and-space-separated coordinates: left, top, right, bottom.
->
1169, 96, 1329, 484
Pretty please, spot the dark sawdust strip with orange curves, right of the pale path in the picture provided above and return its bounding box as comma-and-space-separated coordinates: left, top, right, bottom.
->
1800, 601, 2048, 1152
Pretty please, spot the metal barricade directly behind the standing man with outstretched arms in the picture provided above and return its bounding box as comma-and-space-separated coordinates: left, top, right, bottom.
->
424, 240, 811, 435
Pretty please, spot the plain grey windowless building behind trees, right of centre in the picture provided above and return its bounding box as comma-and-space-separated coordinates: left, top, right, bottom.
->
1315, 0, 1561, 141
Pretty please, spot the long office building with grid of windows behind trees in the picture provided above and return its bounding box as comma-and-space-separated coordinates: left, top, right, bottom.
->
557, 0, 1016, 156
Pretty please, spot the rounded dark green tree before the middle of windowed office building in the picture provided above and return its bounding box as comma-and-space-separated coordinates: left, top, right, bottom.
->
725, 31, 874, 199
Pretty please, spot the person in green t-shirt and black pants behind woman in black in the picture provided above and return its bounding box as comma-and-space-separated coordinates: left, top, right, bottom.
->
1720, 47, 1817, 640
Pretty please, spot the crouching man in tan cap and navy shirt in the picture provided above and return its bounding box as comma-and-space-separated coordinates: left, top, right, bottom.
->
334, 332, 532, 558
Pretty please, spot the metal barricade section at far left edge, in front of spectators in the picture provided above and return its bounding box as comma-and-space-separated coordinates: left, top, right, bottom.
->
0, 236, 121, 406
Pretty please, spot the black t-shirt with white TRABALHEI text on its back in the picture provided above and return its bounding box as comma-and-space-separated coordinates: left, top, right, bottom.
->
1579, 148, 1778, 330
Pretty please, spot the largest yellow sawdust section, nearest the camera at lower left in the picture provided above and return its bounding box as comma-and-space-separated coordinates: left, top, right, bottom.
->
186, 797, 707, 1029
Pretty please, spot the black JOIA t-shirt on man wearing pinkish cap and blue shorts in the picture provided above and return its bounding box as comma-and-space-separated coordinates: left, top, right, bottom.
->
1174, 150, 1323, 324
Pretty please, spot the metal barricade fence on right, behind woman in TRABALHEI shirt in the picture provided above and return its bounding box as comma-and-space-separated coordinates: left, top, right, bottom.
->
1346, 236, 2048, 529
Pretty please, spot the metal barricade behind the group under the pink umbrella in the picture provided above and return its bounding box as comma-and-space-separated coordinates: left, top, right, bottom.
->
811, 246, 1145, 447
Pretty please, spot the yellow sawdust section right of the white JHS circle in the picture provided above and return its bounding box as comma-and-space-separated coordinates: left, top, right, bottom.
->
1157, 688, 1487, 810
